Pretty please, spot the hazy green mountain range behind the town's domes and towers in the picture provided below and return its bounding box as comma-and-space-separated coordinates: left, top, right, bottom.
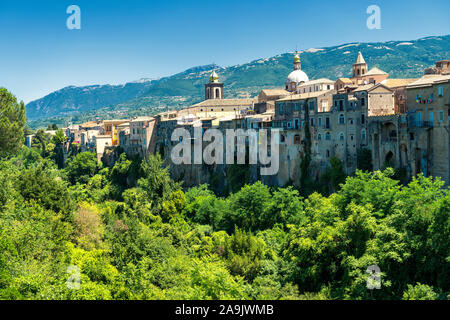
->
26, 35, 450, 127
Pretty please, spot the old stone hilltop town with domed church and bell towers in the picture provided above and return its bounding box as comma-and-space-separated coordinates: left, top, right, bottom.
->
27, 52, 450, 186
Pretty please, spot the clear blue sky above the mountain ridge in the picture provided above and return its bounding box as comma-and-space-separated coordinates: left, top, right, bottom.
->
0, 0, 450, 102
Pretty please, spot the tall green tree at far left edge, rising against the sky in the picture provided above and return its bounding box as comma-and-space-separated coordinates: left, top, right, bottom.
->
0, 88, 26, 157
